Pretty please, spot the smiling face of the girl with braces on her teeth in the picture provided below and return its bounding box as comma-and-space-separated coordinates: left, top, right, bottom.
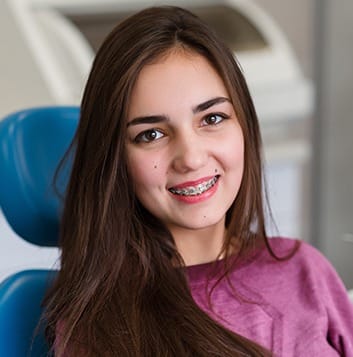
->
127, 51, 244, 253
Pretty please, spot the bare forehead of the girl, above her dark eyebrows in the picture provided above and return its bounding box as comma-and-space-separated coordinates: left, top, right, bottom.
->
129, 50, 229, 117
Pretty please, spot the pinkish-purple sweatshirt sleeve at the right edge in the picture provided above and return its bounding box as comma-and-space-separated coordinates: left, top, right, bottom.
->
309, 242, 353, 357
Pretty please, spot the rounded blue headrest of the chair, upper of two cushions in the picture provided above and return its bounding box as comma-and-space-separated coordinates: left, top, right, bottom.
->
0, 107, 79, 246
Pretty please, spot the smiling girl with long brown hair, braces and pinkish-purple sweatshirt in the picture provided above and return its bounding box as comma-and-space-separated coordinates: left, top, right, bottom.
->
46, 7, 353, 357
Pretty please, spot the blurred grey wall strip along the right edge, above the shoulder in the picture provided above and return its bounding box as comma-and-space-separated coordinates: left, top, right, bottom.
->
314, 0, 353, 289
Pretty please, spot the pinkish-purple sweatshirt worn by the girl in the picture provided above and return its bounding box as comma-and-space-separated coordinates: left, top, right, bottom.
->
188, 238, 353, 357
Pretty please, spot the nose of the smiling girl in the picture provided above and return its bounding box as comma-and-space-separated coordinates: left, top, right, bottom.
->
172, 135, 208, 173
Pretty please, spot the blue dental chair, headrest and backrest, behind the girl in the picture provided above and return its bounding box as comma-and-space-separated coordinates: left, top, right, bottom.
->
0, 107, 79, 357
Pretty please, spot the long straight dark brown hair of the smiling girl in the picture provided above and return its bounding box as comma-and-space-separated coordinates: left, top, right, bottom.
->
45, 7, 288, 357
